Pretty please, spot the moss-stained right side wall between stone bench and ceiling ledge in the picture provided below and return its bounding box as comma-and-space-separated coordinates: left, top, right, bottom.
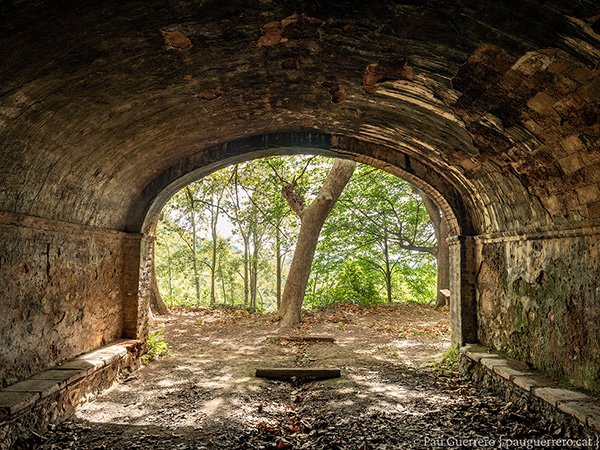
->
476, 228, 600, 395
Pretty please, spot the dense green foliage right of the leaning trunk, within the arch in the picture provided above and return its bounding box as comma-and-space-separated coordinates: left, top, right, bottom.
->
308, 165, 437, 306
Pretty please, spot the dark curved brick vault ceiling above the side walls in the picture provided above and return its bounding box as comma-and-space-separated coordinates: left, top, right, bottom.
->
0, 0, 600, 233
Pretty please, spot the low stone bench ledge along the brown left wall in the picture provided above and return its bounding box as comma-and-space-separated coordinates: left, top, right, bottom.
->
0, 340, 143, 450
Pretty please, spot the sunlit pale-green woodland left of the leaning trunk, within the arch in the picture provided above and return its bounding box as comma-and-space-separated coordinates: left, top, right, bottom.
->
156, 157, 306, 311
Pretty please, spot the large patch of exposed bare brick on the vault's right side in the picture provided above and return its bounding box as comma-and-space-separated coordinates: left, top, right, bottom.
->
448, 44, 600, 228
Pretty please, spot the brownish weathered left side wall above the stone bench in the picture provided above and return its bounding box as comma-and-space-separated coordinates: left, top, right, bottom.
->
0, 213, 139, 387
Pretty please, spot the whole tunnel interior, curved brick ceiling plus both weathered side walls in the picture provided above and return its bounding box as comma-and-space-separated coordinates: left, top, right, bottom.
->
0, 0, 600, 389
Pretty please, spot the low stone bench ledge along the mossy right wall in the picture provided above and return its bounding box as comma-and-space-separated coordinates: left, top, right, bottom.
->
459, 344, 600, 435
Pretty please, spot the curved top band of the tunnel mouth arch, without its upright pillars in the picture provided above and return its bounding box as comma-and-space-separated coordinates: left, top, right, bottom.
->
135, 132, 474, 235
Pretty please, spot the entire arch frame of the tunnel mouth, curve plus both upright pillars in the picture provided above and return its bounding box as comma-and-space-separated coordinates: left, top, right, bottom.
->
126, 133, 477, 344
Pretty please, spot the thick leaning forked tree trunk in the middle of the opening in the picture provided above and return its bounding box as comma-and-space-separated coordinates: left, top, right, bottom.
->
280, 159, 356, 328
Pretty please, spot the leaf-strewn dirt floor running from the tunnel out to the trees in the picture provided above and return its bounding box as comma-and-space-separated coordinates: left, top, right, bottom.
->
31, 304, 580, 450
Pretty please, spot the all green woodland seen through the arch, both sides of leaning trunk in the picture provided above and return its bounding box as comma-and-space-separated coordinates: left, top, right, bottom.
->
155, 156, 437, 311
